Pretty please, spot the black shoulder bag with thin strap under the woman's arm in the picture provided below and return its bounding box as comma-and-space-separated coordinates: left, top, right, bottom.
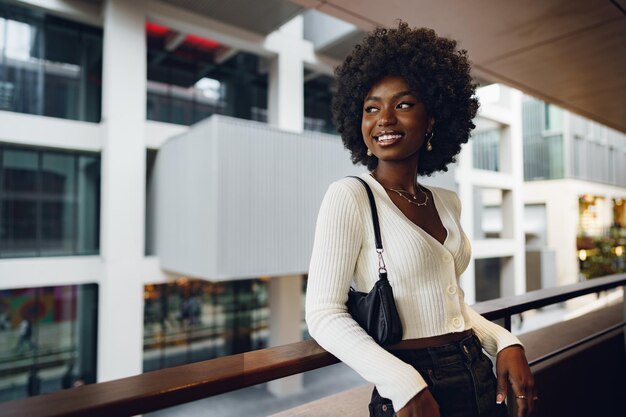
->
346, 177, 402, 346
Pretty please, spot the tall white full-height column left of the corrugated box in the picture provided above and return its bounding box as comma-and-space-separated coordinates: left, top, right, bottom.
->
98, 0, 146, 382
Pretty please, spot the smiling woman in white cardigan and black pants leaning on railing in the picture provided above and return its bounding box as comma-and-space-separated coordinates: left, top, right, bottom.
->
306, 22, 536, 417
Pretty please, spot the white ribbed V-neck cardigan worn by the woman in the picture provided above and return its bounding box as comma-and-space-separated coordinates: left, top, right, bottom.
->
306, 174, 521, 410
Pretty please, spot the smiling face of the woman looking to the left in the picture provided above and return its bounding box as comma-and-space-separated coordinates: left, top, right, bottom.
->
361, 76, 434, 163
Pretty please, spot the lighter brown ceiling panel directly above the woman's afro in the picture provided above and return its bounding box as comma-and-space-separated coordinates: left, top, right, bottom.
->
320, 0, 623, 61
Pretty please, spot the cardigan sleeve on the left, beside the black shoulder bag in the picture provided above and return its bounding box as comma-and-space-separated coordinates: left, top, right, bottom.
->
306, 182, 427, 410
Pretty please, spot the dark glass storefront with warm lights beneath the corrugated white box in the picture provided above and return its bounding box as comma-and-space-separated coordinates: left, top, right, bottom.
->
144, 278, 269, 371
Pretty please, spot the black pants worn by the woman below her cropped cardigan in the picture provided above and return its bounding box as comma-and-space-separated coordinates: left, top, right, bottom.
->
369, 336, 509, 417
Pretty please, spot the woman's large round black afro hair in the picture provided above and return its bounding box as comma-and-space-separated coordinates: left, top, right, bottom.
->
332, 21, 478, 175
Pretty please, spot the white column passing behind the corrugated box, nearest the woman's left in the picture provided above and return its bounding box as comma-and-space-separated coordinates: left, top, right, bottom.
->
265, 16, 307, 396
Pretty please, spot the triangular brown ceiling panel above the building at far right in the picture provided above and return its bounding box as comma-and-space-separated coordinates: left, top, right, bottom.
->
482, 18, 626, 130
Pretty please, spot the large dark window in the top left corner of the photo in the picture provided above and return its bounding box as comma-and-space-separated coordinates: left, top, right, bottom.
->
0, 2, 102, 122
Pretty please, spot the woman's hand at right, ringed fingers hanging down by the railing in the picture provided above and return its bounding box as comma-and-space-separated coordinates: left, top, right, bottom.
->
496, 345, 537, 417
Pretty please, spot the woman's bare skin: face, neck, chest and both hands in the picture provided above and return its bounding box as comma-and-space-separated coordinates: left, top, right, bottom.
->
361, 76, 536, 417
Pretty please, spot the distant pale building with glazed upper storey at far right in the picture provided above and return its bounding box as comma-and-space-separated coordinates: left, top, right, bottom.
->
523, 97, 626, 286
